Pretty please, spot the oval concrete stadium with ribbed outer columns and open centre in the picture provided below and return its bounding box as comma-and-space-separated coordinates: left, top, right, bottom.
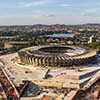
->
18, 45, 97, 67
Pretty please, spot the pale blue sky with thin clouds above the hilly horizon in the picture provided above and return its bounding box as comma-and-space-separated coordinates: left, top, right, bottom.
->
0, 0, 100, 25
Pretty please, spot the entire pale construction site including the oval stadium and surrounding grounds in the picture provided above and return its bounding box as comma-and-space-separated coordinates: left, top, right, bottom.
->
0, 45, 100, 100
